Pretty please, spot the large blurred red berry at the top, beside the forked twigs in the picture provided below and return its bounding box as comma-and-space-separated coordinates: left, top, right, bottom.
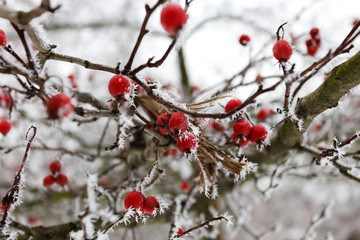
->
160, 4, 187, 36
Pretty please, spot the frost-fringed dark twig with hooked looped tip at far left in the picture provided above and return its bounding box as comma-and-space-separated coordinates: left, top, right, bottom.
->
0, 126, 37, 228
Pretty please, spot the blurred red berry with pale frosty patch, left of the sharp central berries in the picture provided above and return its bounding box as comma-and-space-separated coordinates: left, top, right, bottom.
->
46, 93, 74, 119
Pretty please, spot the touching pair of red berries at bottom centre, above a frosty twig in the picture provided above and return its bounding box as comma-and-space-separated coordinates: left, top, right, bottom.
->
124, 191, 160, 214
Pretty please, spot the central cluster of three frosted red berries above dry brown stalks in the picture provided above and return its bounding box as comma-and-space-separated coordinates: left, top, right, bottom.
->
156, 112, 197, 153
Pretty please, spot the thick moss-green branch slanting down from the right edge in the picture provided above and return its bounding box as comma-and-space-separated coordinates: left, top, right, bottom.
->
249, 52, 360, 164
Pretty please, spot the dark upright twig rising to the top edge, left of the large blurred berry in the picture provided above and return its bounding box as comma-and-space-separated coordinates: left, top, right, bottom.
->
123, 0, 165, 74
